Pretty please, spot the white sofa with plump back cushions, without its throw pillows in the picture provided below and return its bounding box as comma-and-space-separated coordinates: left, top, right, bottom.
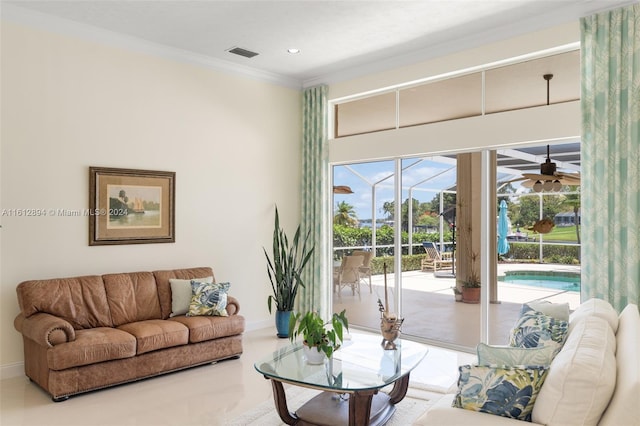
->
414, 299, 640, 426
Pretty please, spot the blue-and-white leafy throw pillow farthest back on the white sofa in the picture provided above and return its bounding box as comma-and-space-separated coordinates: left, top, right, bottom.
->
509, 309, 569, 353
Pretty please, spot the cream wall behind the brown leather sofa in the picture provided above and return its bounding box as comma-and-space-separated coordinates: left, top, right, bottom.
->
0, 22, 301, 371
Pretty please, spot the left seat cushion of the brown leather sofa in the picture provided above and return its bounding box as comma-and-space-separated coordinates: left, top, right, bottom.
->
47, 327, 136, 370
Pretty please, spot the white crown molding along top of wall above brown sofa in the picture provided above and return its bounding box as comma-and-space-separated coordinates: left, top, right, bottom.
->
0, 3, 302, 90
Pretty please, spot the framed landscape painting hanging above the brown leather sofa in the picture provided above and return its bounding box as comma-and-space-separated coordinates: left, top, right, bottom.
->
89, 167, 175, 246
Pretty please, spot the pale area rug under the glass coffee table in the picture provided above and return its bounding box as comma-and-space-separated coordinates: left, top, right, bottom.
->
228, 387, 443, 426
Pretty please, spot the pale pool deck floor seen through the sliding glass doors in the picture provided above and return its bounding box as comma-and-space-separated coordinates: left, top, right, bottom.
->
333, 263, 580, 351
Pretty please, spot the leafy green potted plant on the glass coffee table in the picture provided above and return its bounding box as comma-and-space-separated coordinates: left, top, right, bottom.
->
289, 310, 349, 364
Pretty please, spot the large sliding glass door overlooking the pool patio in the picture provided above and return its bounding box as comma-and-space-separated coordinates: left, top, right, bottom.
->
332, 144, 580, 351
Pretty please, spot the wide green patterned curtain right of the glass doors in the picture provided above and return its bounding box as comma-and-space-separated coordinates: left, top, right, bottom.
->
580, 3, 640, 311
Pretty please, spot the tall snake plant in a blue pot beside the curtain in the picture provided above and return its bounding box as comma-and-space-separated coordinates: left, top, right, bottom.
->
263, 206, 314, 337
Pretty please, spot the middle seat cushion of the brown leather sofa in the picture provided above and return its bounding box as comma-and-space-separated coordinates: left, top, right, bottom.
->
118, 320, 189, 355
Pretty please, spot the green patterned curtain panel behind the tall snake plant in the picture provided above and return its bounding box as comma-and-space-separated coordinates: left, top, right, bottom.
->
296, 86, 331, 317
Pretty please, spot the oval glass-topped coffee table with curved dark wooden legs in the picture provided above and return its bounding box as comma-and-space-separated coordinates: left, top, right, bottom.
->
254, 333, 427, 426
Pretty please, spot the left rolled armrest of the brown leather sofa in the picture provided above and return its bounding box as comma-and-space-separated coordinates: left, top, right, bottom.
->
13, 312, 76, 347
